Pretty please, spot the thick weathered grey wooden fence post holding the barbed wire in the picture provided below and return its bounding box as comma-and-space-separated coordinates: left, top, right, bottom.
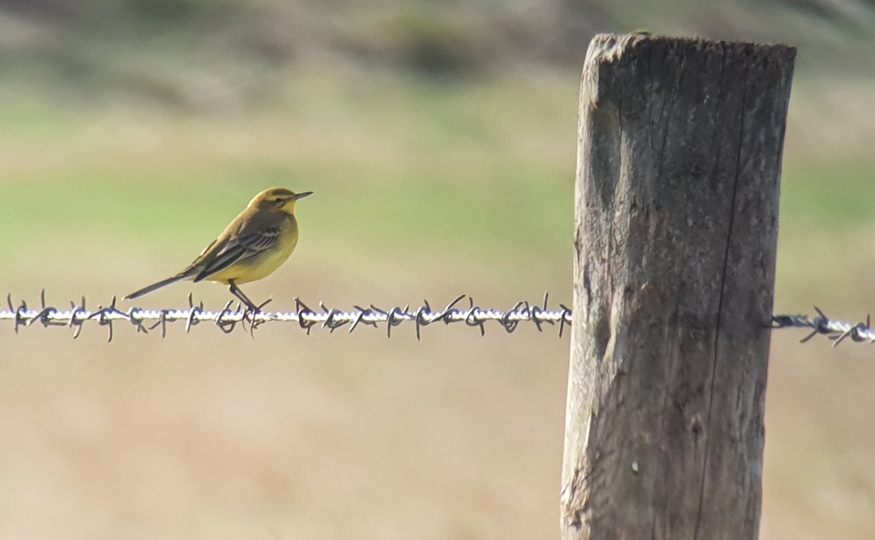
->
561, 34, 796, 540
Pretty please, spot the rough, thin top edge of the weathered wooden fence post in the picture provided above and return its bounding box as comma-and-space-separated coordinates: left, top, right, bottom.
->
586, 32, 796, 63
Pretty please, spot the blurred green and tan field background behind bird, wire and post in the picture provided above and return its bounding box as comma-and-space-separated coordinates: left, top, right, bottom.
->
0, 0, 875, 540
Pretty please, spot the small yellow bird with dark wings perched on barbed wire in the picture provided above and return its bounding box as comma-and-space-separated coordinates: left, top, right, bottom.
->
125, 188, 313, 311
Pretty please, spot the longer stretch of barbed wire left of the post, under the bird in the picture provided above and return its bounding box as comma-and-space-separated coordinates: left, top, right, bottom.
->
0, 290, 571, 341
